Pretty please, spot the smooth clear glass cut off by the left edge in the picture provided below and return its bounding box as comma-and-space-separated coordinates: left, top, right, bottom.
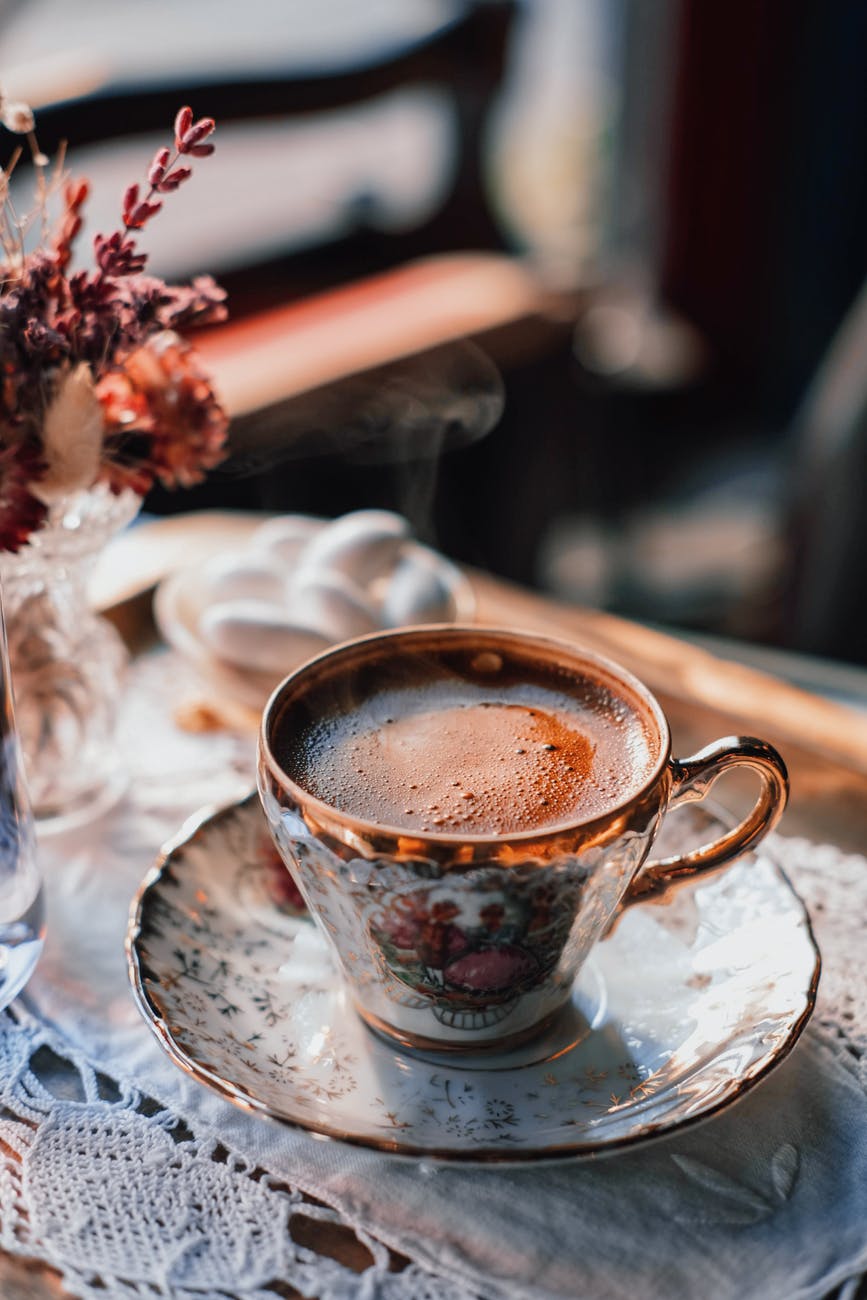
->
0, 590, 43, 1009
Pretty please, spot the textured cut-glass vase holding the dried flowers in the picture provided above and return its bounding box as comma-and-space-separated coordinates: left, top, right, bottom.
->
0, 486, 140, 828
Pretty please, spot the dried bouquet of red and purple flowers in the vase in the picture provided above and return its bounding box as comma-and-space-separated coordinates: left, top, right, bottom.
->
0, 92, 227, 551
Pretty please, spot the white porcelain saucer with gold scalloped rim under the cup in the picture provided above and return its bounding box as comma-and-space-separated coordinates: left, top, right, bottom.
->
127, 796, 819, 1162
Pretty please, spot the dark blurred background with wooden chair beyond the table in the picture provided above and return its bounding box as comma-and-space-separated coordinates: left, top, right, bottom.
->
0, 0, 867, 664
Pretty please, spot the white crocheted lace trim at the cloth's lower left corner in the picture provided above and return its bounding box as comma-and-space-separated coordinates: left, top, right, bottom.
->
0, 1006, 480, 1300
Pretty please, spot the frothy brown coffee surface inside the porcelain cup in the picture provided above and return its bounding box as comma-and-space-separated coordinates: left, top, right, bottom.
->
274, 657, 659, 836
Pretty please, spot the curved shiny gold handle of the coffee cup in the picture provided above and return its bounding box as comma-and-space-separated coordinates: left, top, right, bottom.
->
623, 736, 789, 907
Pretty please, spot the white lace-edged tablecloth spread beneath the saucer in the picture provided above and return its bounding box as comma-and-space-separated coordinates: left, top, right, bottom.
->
0, 655, 867, 1300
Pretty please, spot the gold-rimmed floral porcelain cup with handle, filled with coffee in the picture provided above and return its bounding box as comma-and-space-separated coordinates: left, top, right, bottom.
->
259, 625, 788, 1052
